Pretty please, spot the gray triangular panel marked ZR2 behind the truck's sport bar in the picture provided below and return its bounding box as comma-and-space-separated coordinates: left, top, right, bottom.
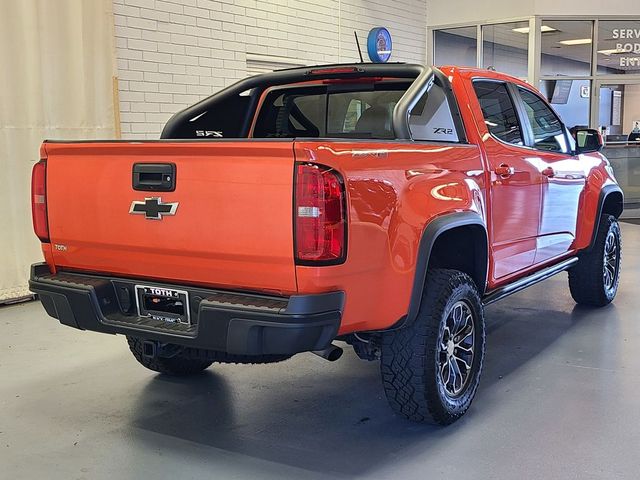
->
409, 83, 460, 142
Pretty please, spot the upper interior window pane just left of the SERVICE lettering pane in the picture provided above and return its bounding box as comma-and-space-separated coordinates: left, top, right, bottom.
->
540, 20, 593, 76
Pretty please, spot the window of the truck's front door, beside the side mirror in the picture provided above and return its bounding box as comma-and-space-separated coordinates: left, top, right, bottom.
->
518, 87, 569, 153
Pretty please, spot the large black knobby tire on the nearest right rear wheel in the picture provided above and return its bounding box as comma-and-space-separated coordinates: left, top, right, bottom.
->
380, 269, 485, 425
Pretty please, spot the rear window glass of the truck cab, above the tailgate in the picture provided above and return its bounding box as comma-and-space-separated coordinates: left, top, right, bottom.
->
253, 82, 409, 139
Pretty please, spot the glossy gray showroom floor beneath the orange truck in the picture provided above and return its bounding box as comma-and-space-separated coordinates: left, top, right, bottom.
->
0, 224, 640, 480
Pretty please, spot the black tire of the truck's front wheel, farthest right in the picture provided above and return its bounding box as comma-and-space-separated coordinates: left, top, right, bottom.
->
569, 214, 622, 307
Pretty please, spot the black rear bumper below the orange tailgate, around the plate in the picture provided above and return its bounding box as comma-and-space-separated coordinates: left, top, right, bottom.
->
29, 263, 344, 355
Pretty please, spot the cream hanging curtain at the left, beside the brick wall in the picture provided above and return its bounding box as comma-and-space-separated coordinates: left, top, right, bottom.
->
0, 0, 115, 303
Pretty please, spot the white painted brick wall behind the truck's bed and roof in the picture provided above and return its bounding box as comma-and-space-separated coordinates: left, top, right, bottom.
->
113, 0, 426, 139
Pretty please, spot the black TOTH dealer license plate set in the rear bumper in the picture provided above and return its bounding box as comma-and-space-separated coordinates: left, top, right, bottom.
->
136, 285, 191, 325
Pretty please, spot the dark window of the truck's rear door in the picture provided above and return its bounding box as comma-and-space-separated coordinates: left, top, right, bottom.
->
473, 81, 524, 145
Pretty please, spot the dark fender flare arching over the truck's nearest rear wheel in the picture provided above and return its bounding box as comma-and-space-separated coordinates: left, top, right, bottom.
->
399, 211, 489, 325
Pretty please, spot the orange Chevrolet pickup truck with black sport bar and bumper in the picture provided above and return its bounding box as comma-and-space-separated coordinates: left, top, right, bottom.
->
30, 64, 623, 424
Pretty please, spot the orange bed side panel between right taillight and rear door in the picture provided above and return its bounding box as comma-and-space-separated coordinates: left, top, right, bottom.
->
295, 141, 486, 333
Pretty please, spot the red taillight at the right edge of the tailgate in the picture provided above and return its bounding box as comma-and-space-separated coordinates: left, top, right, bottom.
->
294, 163, 347, 265
